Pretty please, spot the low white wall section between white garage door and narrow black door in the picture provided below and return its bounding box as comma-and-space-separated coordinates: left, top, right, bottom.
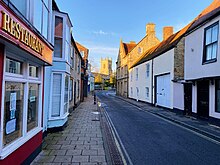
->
173, 83, 184, 110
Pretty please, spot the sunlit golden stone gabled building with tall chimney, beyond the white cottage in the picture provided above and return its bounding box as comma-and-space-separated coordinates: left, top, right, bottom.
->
116, 23, 160, 97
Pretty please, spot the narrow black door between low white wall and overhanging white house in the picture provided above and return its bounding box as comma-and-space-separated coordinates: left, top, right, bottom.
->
184, 84, 192, 116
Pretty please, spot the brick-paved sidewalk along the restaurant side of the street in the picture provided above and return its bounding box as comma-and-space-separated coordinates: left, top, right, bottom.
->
32, 96, 107, 165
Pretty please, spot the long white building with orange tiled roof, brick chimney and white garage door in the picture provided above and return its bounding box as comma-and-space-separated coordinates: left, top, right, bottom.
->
129, 26, 188, 110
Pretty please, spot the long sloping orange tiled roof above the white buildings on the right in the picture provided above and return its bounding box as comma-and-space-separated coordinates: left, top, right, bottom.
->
130, 0, 220, 68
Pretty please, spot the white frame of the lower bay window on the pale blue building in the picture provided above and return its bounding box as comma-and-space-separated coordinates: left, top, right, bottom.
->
49, 70, 70, 120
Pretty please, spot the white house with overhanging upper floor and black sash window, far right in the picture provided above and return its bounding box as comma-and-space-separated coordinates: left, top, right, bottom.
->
184, 0, 220, 119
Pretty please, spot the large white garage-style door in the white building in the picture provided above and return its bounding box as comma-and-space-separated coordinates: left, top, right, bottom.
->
156, 74, 171, 108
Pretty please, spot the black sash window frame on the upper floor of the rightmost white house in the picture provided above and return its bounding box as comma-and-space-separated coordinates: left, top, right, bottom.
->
202, 21, 219, 65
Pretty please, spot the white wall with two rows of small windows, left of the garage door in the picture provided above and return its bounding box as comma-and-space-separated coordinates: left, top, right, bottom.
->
128, 60, 152, 103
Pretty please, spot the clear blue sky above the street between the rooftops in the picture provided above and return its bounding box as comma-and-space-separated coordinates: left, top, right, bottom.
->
56, 0, 212, 70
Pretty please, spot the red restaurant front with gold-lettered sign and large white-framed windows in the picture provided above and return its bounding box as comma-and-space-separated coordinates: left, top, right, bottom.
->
0, 0, 53, 164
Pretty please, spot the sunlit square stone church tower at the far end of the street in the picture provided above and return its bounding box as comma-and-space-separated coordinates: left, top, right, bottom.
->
100, 58, 112, 76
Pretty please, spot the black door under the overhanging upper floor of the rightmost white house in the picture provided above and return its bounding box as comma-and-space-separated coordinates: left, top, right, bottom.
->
197, 80, 209, 118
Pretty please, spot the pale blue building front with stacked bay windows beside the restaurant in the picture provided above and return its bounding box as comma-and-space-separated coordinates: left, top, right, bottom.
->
44, 3, 72, 130
